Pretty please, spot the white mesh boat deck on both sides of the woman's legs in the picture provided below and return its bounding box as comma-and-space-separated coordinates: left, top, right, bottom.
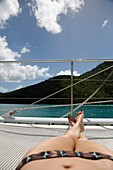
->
0, 123, 113, 170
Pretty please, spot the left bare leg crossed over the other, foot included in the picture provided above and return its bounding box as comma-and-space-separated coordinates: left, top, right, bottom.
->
25, 113, 84, 157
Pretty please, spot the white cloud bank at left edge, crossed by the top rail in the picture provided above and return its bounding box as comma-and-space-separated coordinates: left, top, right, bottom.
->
0, 36, 50, 82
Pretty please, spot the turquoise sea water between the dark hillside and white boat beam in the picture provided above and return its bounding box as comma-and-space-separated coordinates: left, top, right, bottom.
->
0, 104, 113, 118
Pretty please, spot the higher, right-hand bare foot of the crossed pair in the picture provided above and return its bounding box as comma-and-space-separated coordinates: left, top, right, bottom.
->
76, 111, 84, 132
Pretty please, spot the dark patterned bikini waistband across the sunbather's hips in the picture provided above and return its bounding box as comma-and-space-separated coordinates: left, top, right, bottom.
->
16, 150, 113, 170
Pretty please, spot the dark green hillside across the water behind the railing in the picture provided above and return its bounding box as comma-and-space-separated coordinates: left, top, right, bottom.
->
0, 62, 113, 104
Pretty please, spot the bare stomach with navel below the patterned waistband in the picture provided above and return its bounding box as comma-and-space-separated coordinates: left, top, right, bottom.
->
21, 158, 113, 170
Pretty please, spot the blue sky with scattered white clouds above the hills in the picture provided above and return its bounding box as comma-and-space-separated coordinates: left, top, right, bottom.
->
0, 0, 113, 92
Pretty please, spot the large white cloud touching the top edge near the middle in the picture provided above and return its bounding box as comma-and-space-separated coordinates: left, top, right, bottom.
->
29, 0, 84, 34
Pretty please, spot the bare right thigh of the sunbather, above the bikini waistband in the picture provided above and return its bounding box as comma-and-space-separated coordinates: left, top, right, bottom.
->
75, 140, 113, 156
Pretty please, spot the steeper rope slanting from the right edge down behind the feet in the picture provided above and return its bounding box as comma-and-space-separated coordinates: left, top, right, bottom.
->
61, 71, 113, 118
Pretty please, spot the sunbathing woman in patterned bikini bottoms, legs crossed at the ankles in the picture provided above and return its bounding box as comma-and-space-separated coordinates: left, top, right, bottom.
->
16, 111, 113, 170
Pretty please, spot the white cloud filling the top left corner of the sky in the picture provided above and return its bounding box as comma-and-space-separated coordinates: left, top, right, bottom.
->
0, 0, 22, 28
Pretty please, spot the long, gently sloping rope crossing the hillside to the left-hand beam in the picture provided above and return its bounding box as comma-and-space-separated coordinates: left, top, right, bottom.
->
14, 65, 113, 112
